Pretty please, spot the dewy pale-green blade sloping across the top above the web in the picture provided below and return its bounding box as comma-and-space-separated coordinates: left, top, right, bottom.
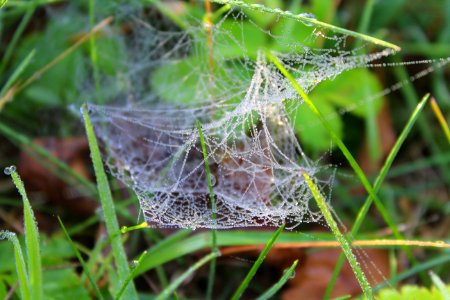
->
211, 0, 401, 51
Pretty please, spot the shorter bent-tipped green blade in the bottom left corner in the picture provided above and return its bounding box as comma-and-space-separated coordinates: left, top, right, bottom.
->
0, 231, 31, 300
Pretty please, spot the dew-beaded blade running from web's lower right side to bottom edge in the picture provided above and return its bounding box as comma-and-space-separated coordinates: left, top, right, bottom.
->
303, 171, 373, 299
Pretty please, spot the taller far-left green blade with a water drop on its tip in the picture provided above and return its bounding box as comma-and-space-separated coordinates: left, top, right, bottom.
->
5, 166, 43, 300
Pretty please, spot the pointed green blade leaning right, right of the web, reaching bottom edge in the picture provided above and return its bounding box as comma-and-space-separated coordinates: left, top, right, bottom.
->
324, 94, 430, 299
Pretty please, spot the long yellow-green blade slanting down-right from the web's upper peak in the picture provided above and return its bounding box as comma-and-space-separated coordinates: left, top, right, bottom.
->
267, 52, 403, 244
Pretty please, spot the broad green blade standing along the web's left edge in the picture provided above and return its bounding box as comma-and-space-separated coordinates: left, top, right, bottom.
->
82, 105, 137, 299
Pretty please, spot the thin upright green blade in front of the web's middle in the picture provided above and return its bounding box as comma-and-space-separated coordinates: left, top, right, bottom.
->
197, 120, 219, 299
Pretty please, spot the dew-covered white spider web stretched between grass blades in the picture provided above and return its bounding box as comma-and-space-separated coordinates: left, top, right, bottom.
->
89, 1, 391, 228
